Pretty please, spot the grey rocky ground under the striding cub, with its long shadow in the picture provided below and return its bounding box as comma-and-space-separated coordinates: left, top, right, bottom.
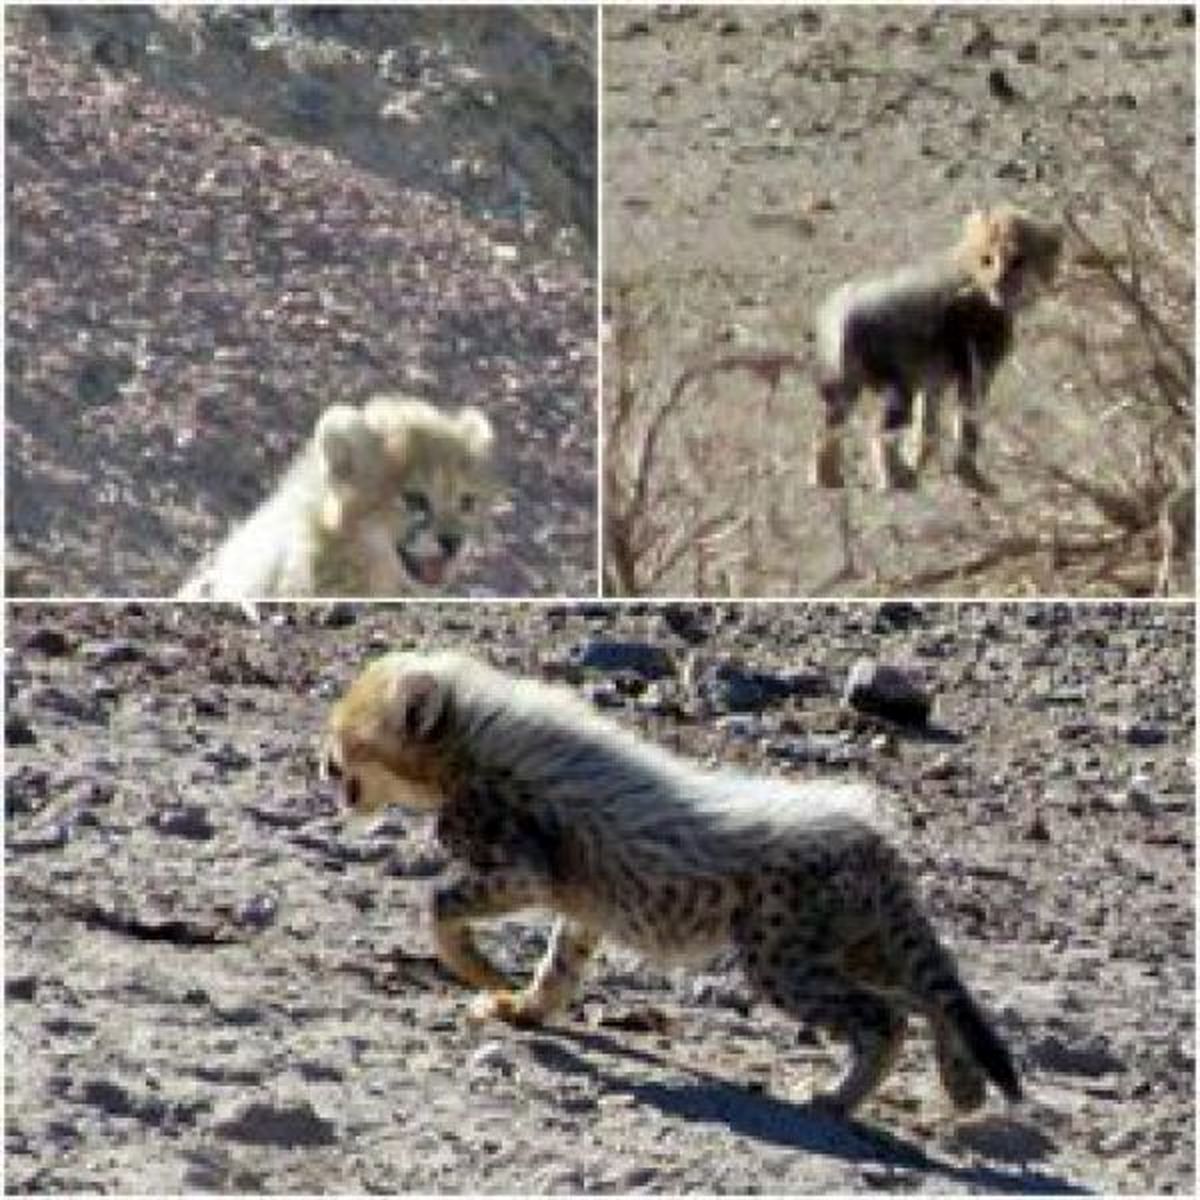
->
5, 604, 1195, 1193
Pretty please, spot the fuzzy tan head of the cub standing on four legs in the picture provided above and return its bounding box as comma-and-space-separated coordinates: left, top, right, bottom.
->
958, 204, 1062, 312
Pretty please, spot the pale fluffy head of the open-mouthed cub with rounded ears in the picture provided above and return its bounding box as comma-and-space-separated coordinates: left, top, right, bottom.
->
317, 396, 492, 590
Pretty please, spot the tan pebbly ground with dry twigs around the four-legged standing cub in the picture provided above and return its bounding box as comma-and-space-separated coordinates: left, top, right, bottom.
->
601, 5, 1195, 596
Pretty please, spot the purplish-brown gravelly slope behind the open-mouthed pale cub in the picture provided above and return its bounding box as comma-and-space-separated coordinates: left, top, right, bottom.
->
5, 6, 596, 596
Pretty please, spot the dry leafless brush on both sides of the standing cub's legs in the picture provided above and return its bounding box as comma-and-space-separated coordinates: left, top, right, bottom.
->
605, 150, 1195, 595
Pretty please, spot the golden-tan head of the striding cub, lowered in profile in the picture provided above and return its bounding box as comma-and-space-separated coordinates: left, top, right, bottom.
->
322, 654, 450, 817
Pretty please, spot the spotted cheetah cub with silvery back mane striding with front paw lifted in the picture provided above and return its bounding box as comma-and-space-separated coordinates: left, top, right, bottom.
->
325, 653, 1020, 1114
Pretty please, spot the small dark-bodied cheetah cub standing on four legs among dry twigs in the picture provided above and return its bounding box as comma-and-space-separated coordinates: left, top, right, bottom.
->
814, 204, 1062, 492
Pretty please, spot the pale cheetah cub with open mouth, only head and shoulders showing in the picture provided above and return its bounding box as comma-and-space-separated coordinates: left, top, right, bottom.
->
179, 396, 492, 600
